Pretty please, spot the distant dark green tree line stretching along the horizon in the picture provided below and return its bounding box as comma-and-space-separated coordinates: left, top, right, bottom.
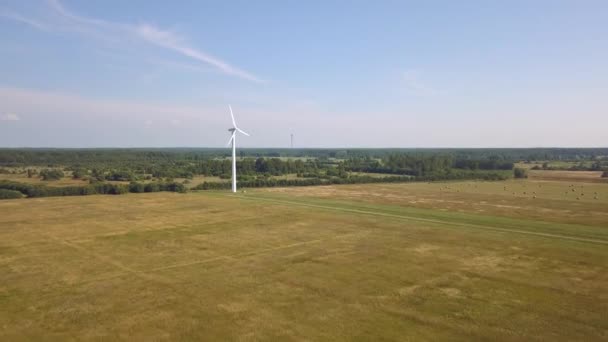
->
0, 148, 608, 168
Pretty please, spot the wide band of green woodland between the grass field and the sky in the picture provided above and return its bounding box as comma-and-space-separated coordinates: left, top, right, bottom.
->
0, 148, 608, 198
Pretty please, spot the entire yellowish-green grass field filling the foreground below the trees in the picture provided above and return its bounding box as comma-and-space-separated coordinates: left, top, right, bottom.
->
0, 180, 608, 341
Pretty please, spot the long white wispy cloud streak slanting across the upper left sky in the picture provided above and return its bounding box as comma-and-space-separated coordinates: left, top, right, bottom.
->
0, 0, 265, 83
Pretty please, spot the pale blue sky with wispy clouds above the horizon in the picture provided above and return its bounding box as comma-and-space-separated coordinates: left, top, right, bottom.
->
0, 0, 608, 147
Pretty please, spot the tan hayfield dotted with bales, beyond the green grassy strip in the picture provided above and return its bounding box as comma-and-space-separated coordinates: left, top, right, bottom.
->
259, 180, 608, 227
